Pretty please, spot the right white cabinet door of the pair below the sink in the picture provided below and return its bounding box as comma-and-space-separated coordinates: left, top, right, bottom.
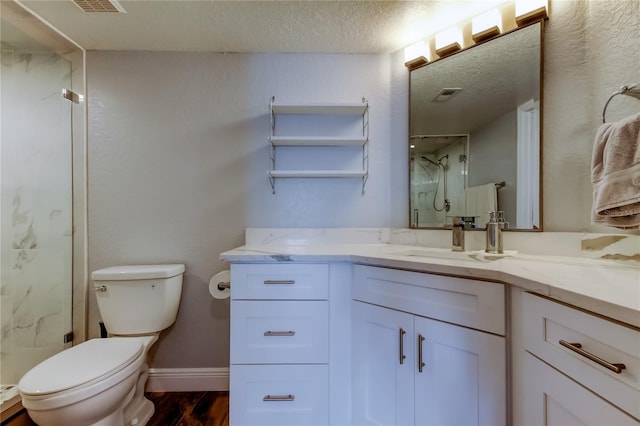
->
415, 317, 506, 426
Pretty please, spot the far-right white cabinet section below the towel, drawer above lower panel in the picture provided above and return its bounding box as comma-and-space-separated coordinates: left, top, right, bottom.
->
514, 292, 640, 426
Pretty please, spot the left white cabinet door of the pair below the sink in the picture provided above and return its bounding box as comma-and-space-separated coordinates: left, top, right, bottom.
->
352, 302, 415, 426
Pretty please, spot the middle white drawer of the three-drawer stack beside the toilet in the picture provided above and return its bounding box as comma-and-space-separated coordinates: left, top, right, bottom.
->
231, 300, 329, 364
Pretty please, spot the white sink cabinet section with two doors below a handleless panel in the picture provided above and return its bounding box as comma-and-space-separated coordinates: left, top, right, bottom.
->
352, 265, 507, 426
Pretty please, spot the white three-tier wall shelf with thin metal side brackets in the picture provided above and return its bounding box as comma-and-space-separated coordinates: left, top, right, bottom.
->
269, 97, 369, 194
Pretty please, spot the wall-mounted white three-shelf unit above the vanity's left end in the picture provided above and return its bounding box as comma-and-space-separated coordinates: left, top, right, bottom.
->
269, 98, 369, 194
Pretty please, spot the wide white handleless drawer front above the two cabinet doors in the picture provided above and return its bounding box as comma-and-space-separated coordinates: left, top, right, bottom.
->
353, 265, 505, 335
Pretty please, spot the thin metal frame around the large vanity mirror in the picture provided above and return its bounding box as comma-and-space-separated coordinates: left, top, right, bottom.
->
407, 18, 545, 232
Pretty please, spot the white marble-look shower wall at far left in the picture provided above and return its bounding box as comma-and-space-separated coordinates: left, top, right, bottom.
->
0, 48, 73, 384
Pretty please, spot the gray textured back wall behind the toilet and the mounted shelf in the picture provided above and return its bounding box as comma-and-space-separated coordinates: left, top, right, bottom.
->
87, 52, 396, 367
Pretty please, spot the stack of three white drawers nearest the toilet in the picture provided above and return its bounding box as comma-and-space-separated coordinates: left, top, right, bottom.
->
229, 264, 329, 426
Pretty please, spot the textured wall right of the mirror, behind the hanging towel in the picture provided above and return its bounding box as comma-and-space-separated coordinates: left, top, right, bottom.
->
543, 0, 640, 232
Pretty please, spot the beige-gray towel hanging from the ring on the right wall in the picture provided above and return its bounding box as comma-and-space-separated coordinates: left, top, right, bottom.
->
591, 114, 640, 229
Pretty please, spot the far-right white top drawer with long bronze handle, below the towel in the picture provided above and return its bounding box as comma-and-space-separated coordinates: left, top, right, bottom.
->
522, 293, 640, 418
